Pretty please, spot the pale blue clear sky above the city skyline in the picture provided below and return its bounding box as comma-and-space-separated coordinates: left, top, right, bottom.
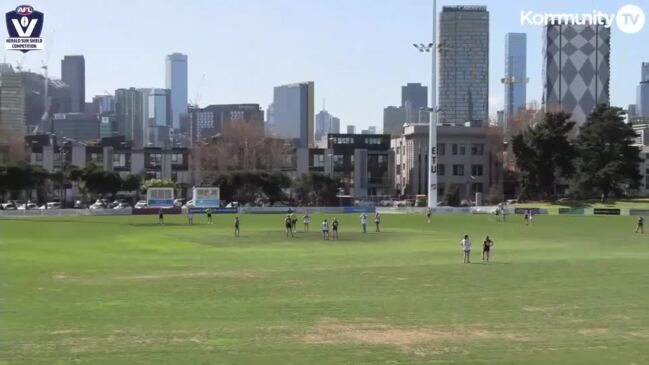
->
0, 0, 649, 128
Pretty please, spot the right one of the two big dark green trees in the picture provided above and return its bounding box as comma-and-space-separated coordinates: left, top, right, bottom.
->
575, 104, 642, 199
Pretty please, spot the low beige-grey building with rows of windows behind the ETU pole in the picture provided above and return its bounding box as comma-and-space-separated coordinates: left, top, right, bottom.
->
391, 124, 500, 200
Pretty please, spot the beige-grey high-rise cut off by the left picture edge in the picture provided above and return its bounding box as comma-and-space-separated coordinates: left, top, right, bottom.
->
0, 70, 25, 163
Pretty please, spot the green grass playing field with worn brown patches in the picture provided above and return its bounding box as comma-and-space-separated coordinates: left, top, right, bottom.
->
0, 215, 649, 365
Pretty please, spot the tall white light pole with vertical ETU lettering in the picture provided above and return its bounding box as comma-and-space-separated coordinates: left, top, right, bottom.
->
413, 0, 438, 208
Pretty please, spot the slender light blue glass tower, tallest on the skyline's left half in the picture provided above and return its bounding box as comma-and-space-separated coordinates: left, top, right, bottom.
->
165, 53, 187, 129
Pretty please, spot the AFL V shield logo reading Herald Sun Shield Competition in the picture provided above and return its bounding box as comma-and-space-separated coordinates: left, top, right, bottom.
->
5, 5, 43, 53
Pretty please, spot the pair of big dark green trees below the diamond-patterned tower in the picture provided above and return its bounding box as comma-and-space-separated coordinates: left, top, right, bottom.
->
512, 105, 642, 200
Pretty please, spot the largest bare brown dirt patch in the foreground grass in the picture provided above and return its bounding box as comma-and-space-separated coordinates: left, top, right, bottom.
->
301, 319, 524, 356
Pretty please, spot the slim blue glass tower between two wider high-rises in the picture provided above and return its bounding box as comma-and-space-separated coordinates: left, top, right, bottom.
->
501, 33, 528, 128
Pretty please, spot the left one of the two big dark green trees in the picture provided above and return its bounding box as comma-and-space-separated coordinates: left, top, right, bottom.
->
512, 112, 576, 199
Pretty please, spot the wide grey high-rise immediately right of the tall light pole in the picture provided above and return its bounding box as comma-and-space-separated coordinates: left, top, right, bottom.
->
439, 6, 489, 125
